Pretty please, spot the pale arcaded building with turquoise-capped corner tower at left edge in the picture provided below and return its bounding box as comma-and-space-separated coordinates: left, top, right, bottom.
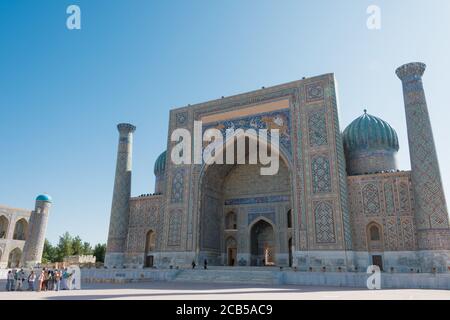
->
0, 194, 52, 268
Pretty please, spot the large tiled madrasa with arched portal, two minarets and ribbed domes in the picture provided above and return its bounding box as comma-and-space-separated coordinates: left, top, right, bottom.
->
105, 63, 450, 272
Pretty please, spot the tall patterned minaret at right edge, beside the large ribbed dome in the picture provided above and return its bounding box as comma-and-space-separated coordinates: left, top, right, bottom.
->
396, 62, 450, 258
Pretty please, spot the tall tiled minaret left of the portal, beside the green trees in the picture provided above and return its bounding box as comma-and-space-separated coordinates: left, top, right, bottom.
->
105, 123, 136, 268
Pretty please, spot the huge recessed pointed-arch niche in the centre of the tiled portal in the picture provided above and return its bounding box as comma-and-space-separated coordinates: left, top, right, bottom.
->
197, 135, 292, 266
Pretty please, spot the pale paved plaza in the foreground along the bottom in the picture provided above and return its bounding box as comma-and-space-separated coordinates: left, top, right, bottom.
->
0, 282, 450, 300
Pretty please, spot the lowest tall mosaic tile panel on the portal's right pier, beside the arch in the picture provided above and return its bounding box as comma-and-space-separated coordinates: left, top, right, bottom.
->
314, 201, 336, 243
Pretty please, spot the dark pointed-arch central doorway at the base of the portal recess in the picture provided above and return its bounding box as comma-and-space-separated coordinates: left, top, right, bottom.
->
250, 220, 275, 266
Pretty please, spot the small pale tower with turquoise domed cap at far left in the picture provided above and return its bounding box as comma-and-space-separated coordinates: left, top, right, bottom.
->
22, 194, 52, 267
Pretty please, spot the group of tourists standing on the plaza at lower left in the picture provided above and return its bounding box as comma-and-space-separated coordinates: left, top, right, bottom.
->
6, 268, 73, 291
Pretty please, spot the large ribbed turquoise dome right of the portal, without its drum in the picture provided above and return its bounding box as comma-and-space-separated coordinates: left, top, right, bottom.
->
343, 110, 399, 153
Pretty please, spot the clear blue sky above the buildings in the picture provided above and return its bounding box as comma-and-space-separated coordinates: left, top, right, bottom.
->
0, 0, 450, 243
